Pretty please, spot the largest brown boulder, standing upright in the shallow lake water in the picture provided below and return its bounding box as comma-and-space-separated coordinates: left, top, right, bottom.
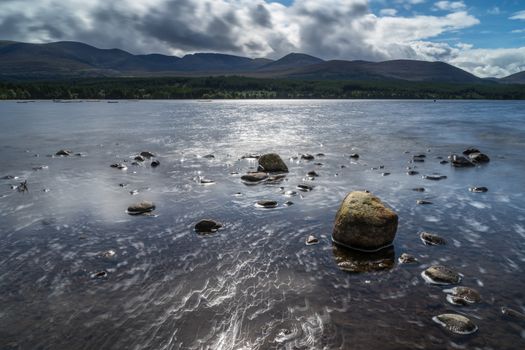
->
332, 191, 398, 251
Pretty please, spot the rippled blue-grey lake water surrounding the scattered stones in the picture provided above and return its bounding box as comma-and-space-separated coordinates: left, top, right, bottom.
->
0, 100, 525, 350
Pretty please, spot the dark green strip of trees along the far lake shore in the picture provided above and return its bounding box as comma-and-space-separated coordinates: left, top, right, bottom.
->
0, 76, 525, 100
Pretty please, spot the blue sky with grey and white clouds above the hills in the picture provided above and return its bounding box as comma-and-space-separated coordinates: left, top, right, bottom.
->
0, 0, 525, 77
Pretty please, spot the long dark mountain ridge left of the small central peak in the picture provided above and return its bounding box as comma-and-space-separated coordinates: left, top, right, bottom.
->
0, 41, 272, 79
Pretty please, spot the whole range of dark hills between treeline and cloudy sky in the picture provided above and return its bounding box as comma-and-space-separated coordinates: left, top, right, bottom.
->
0, 41, 498, 83
